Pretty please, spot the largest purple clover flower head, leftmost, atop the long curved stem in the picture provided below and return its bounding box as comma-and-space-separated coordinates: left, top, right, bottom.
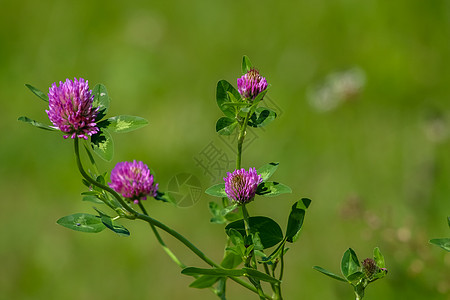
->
45, 78, 99, 140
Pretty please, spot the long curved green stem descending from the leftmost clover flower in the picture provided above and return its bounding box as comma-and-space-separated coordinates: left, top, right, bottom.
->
74, 139, 271, 299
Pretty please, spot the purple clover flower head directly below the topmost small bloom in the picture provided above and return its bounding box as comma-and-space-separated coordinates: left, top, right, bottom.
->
223, 168, 262, 204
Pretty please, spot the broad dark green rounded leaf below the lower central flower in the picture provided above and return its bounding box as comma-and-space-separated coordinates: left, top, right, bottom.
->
225, 216, 283, 249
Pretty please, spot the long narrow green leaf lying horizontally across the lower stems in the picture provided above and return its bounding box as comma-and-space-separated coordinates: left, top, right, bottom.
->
181, 267, 280, 283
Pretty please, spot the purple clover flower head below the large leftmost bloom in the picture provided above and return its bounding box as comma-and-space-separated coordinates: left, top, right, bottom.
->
108, 160, 158, 204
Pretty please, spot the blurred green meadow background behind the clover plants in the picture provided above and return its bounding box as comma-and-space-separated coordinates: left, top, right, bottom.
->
0, 0, 450, 300
